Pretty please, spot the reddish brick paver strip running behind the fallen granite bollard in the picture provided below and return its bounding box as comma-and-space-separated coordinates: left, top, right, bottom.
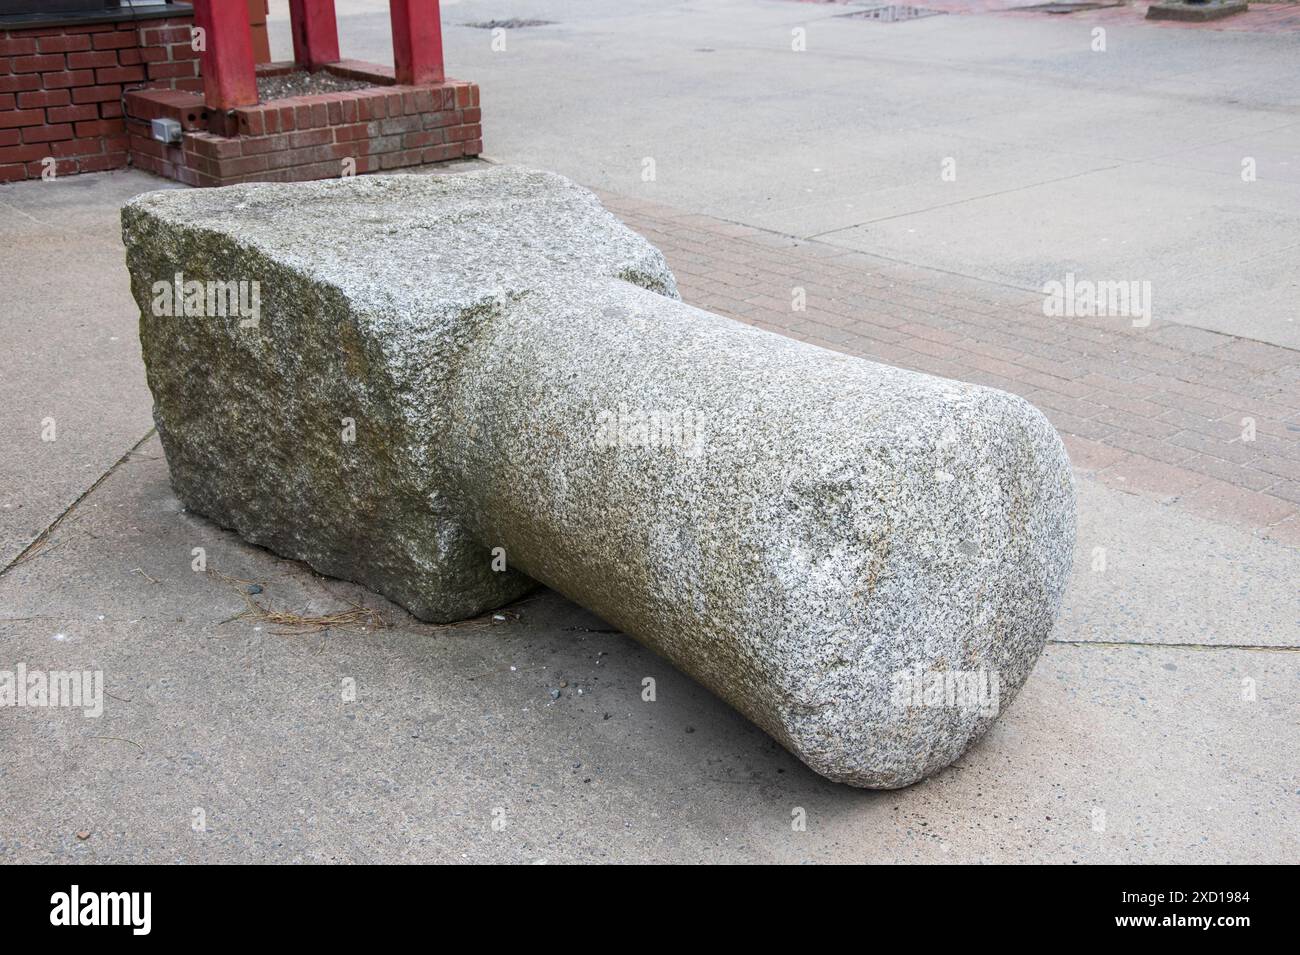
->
602, 194, 1300, 543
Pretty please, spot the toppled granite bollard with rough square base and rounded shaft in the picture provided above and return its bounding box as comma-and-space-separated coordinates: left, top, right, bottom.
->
122, 168, 1074, 786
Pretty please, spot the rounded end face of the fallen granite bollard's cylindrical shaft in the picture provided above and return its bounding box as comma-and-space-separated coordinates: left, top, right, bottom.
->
771, 379, 1075, 789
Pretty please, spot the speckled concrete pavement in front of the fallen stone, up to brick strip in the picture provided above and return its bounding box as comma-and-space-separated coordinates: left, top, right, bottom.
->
0, 440, 1300, 863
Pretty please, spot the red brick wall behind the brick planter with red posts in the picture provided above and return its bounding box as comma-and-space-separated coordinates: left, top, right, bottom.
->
0, 17, 203, 182
